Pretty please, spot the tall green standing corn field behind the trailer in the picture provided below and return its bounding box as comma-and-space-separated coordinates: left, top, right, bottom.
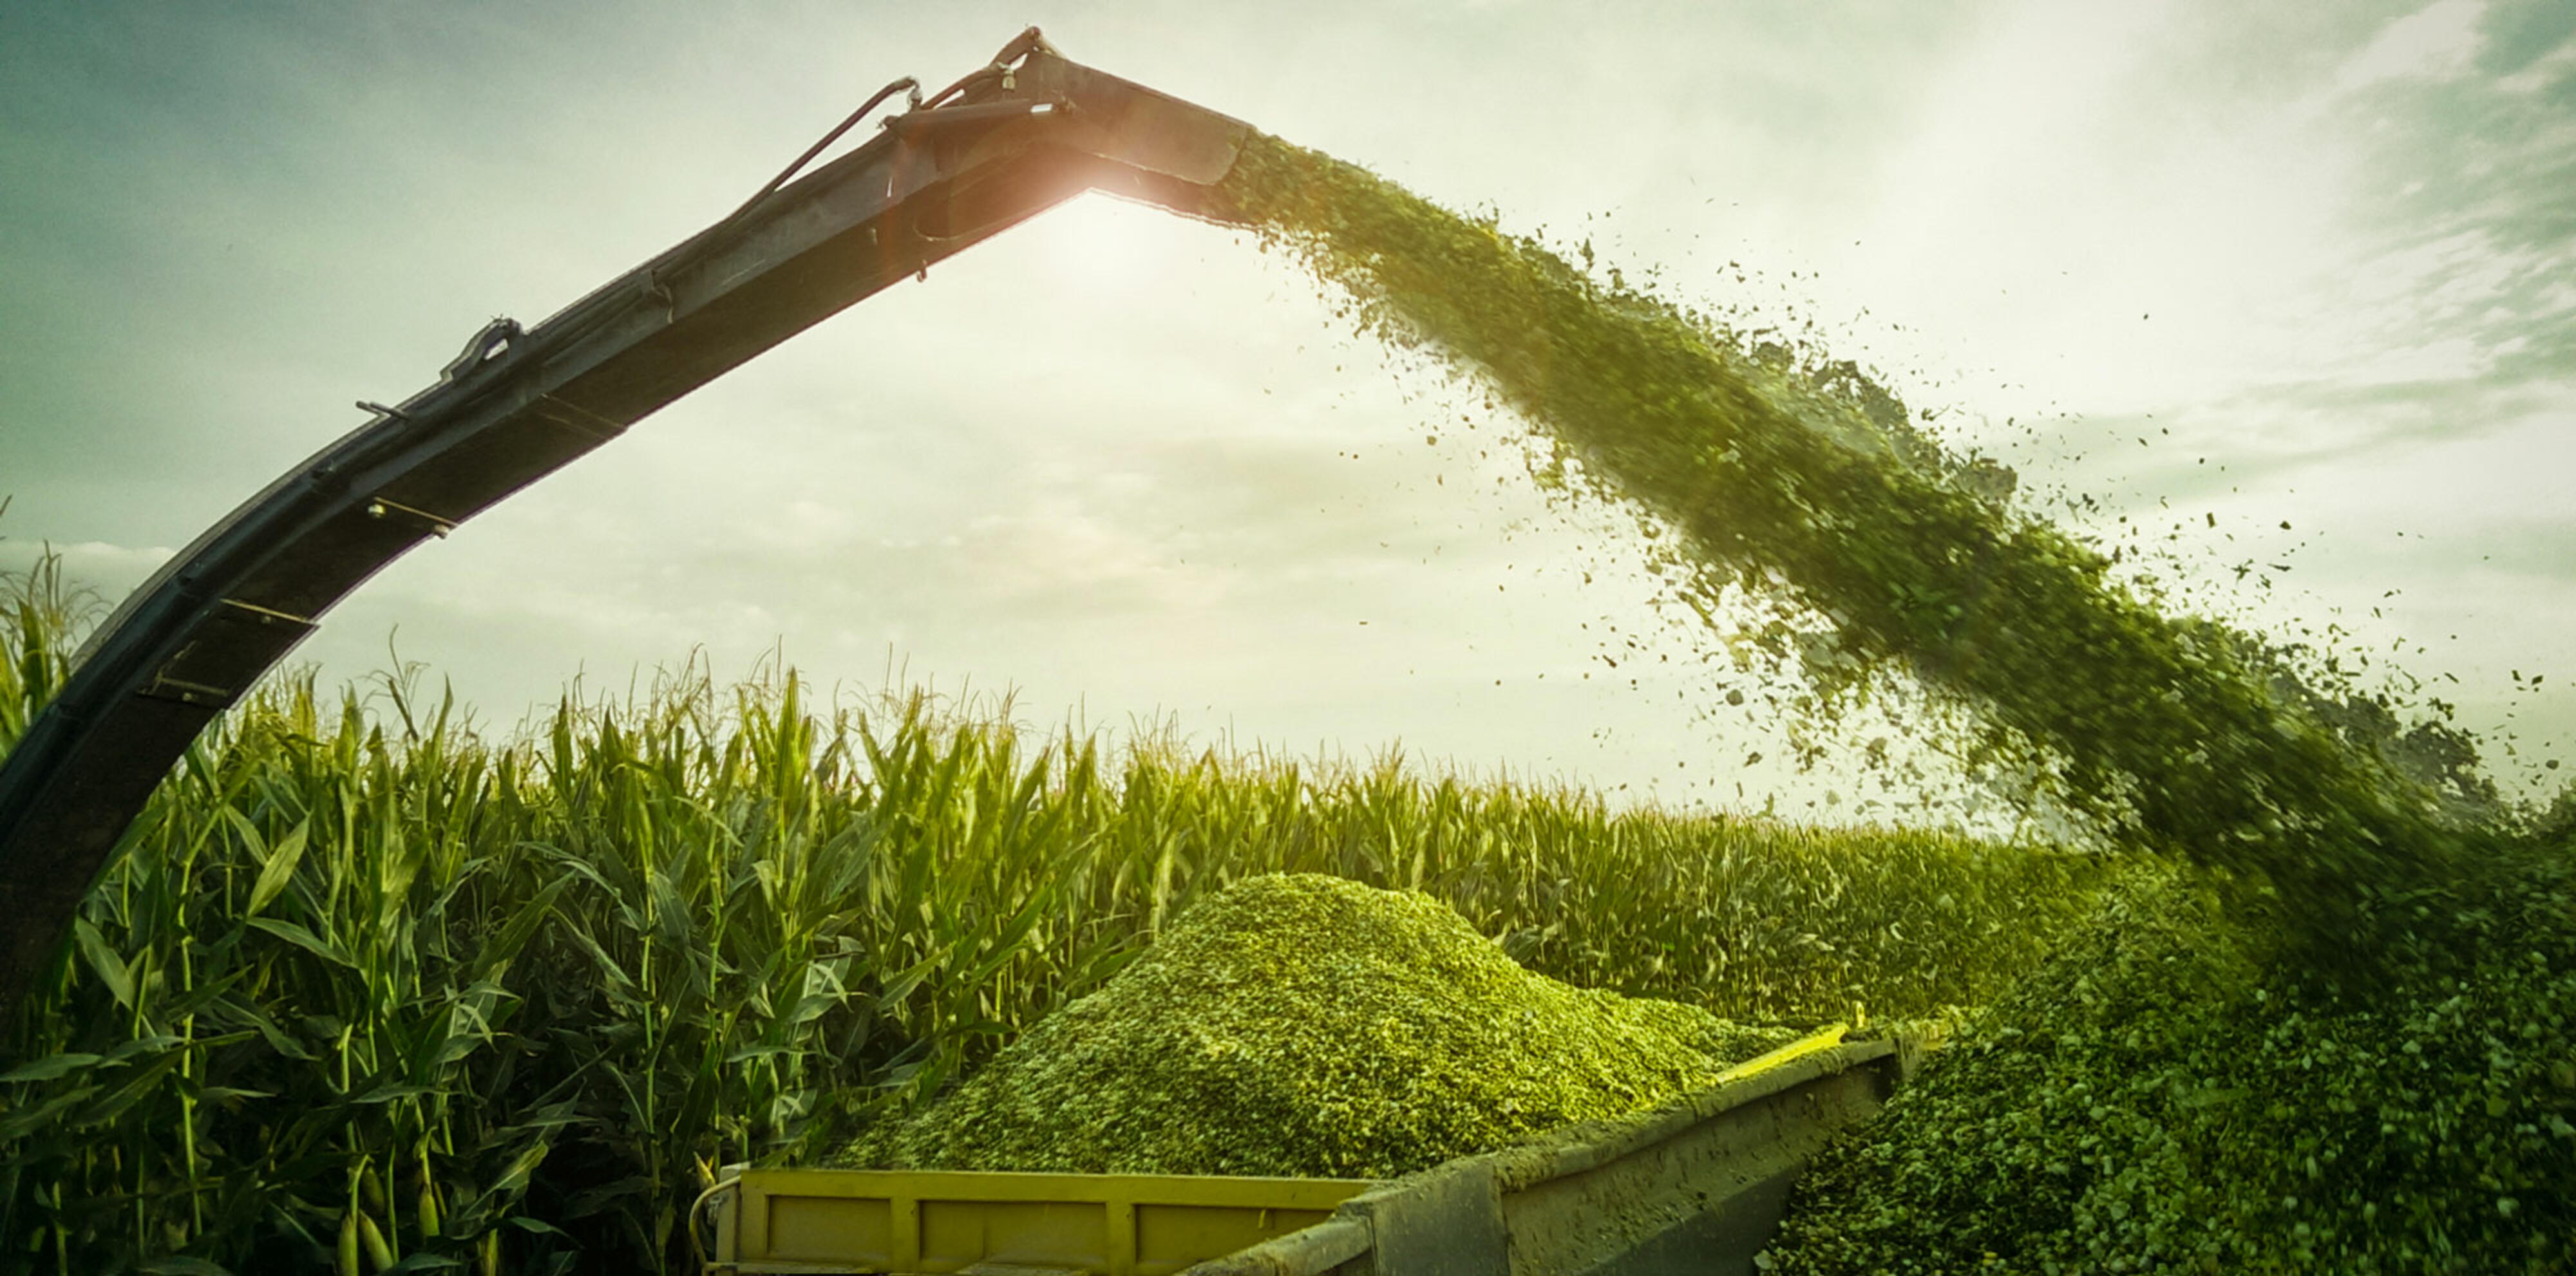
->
0, 566, 2105, 1273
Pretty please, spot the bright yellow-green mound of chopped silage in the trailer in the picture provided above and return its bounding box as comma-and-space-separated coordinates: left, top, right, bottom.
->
842, 875, 1798, 1178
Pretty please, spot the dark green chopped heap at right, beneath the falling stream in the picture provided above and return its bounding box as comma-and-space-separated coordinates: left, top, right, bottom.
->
1762, 844, 2576, 1276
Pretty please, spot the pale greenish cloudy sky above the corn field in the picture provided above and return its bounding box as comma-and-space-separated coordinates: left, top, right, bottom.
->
0, 0, 2576, 818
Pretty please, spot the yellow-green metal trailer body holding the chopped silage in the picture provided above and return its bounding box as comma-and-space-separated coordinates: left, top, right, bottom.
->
708, 1026, 1922, 1276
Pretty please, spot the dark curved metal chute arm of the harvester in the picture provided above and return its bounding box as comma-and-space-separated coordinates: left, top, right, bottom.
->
0, 28, 1249, 1013
